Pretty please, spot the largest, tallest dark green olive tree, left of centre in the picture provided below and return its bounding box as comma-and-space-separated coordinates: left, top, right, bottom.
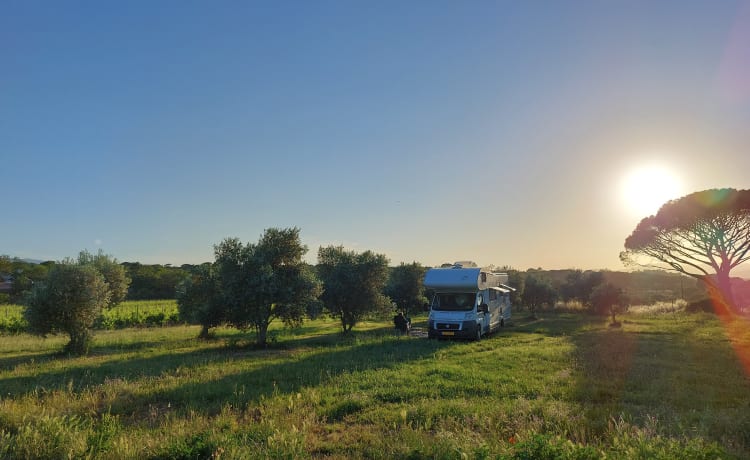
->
214, 228, 320, 346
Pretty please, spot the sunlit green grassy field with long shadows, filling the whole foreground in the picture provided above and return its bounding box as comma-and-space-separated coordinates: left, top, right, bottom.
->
0, 314, 750, 459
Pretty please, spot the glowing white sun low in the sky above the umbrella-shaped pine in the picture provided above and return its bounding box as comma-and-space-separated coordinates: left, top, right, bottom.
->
620, 165, 683, 217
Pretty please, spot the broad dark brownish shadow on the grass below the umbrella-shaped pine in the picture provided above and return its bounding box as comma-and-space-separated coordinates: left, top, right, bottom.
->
572, 318, 750, 453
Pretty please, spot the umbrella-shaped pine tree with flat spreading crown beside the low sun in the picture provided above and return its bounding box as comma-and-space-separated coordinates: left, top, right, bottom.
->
620, 188, 750, 306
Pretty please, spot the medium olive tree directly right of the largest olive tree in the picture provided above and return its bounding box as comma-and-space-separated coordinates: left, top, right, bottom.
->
317, 246, 390, 332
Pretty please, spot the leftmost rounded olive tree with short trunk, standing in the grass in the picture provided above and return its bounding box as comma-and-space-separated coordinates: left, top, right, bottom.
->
25, 263, 111, 354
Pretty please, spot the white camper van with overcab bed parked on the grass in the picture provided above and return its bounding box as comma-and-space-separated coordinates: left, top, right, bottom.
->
424, 262, 514, 340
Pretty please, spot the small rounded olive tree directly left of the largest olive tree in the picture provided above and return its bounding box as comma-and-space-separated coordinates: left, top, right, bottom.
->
177, 265, 228, 338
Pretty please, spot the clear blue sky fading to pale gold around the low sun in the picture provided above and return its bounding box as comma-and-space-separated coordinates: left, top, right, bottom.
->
0, 0, 750, 270
